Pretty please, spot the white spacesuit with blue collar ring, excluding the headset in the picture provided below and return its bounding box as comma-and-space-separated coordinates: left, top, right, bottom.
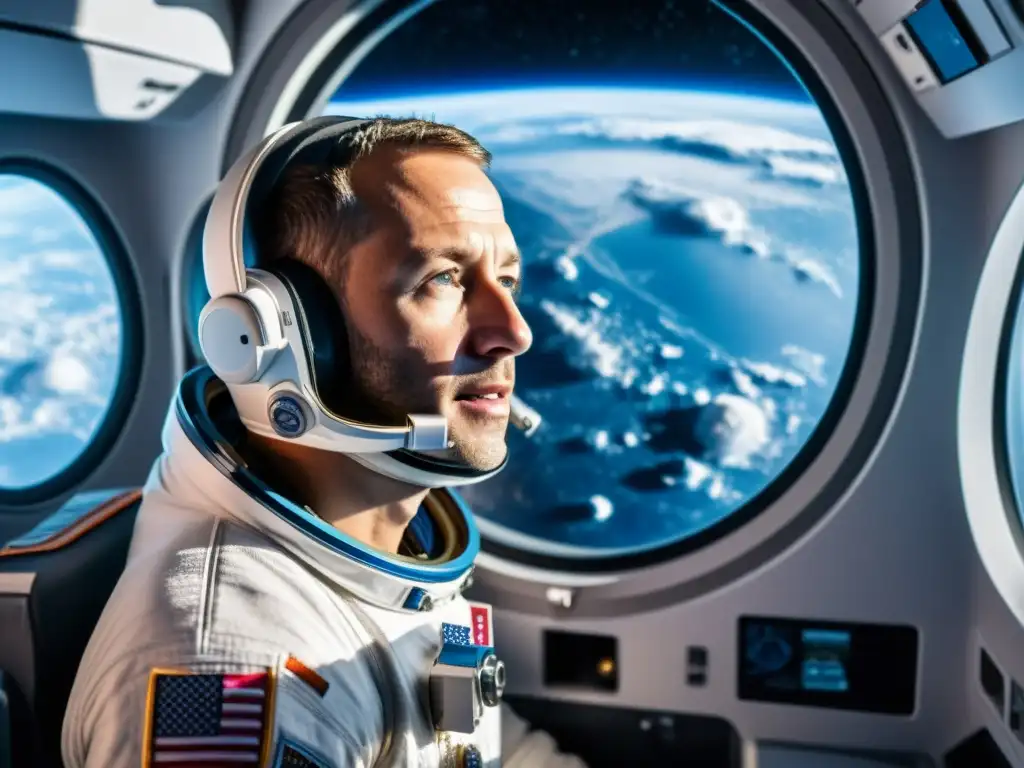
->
62, 370, 582, 768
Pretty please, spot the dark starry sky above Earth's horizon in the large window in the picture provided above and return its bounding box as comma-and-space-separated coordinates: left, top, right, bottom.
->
339, 0, 803, 98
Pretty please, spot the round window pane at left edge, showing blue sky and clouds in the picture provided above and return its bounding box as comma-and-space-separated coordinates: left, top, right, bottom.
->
0, 166, 130, 495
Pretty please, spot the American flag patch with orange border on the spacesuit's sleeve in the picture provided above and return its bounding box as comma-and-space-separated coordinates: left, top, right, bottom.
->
145, 671, 273, 768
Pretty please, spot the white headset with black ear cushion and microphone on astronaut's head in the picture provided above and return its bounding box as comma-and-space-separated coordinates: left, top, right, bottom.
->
199, 117, 541, 487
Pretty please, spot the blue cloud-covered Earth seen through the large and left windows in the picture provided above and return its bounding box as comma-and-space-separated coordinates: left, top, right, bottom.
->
0, 87, 859, 558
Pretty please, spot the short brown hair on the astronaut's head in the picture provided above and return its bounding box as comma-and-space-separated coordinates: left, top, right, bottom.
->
254, 117, 490, 290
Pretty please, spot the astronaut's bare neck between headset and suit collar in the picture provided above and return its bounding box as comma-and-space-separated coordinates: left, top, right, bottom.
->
248, 435, 428, 554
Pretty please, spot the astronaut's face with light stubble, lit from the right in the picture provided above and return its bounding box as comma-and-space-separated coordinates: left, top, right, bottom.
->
342, 148, 532, 469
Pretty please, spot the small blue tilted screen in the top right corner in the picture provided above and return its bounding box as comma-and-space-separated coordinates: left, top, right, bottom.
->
903, 0, 986, 84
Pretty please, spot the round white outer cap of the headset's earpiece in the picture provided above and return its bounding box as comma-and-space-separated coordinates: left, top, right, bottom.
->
199, 296, 271, 384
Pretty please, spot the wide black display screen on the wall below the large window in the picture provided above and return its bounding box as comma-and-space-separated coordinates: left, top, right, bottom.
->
738, 616, 918, 715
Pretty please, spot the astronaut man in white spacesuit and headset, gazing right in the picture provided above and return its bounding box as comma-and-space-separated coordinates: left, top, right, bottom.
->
61, 118, 584, 768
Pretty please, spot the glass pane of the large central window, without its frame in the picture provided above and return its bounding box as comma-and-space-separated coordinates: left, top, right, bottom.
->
319, 0, 861, 560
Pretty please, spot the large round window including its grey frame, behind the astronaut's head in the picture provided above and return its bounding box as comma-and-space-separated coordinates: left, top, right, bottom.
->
218, 0, 888, 577
